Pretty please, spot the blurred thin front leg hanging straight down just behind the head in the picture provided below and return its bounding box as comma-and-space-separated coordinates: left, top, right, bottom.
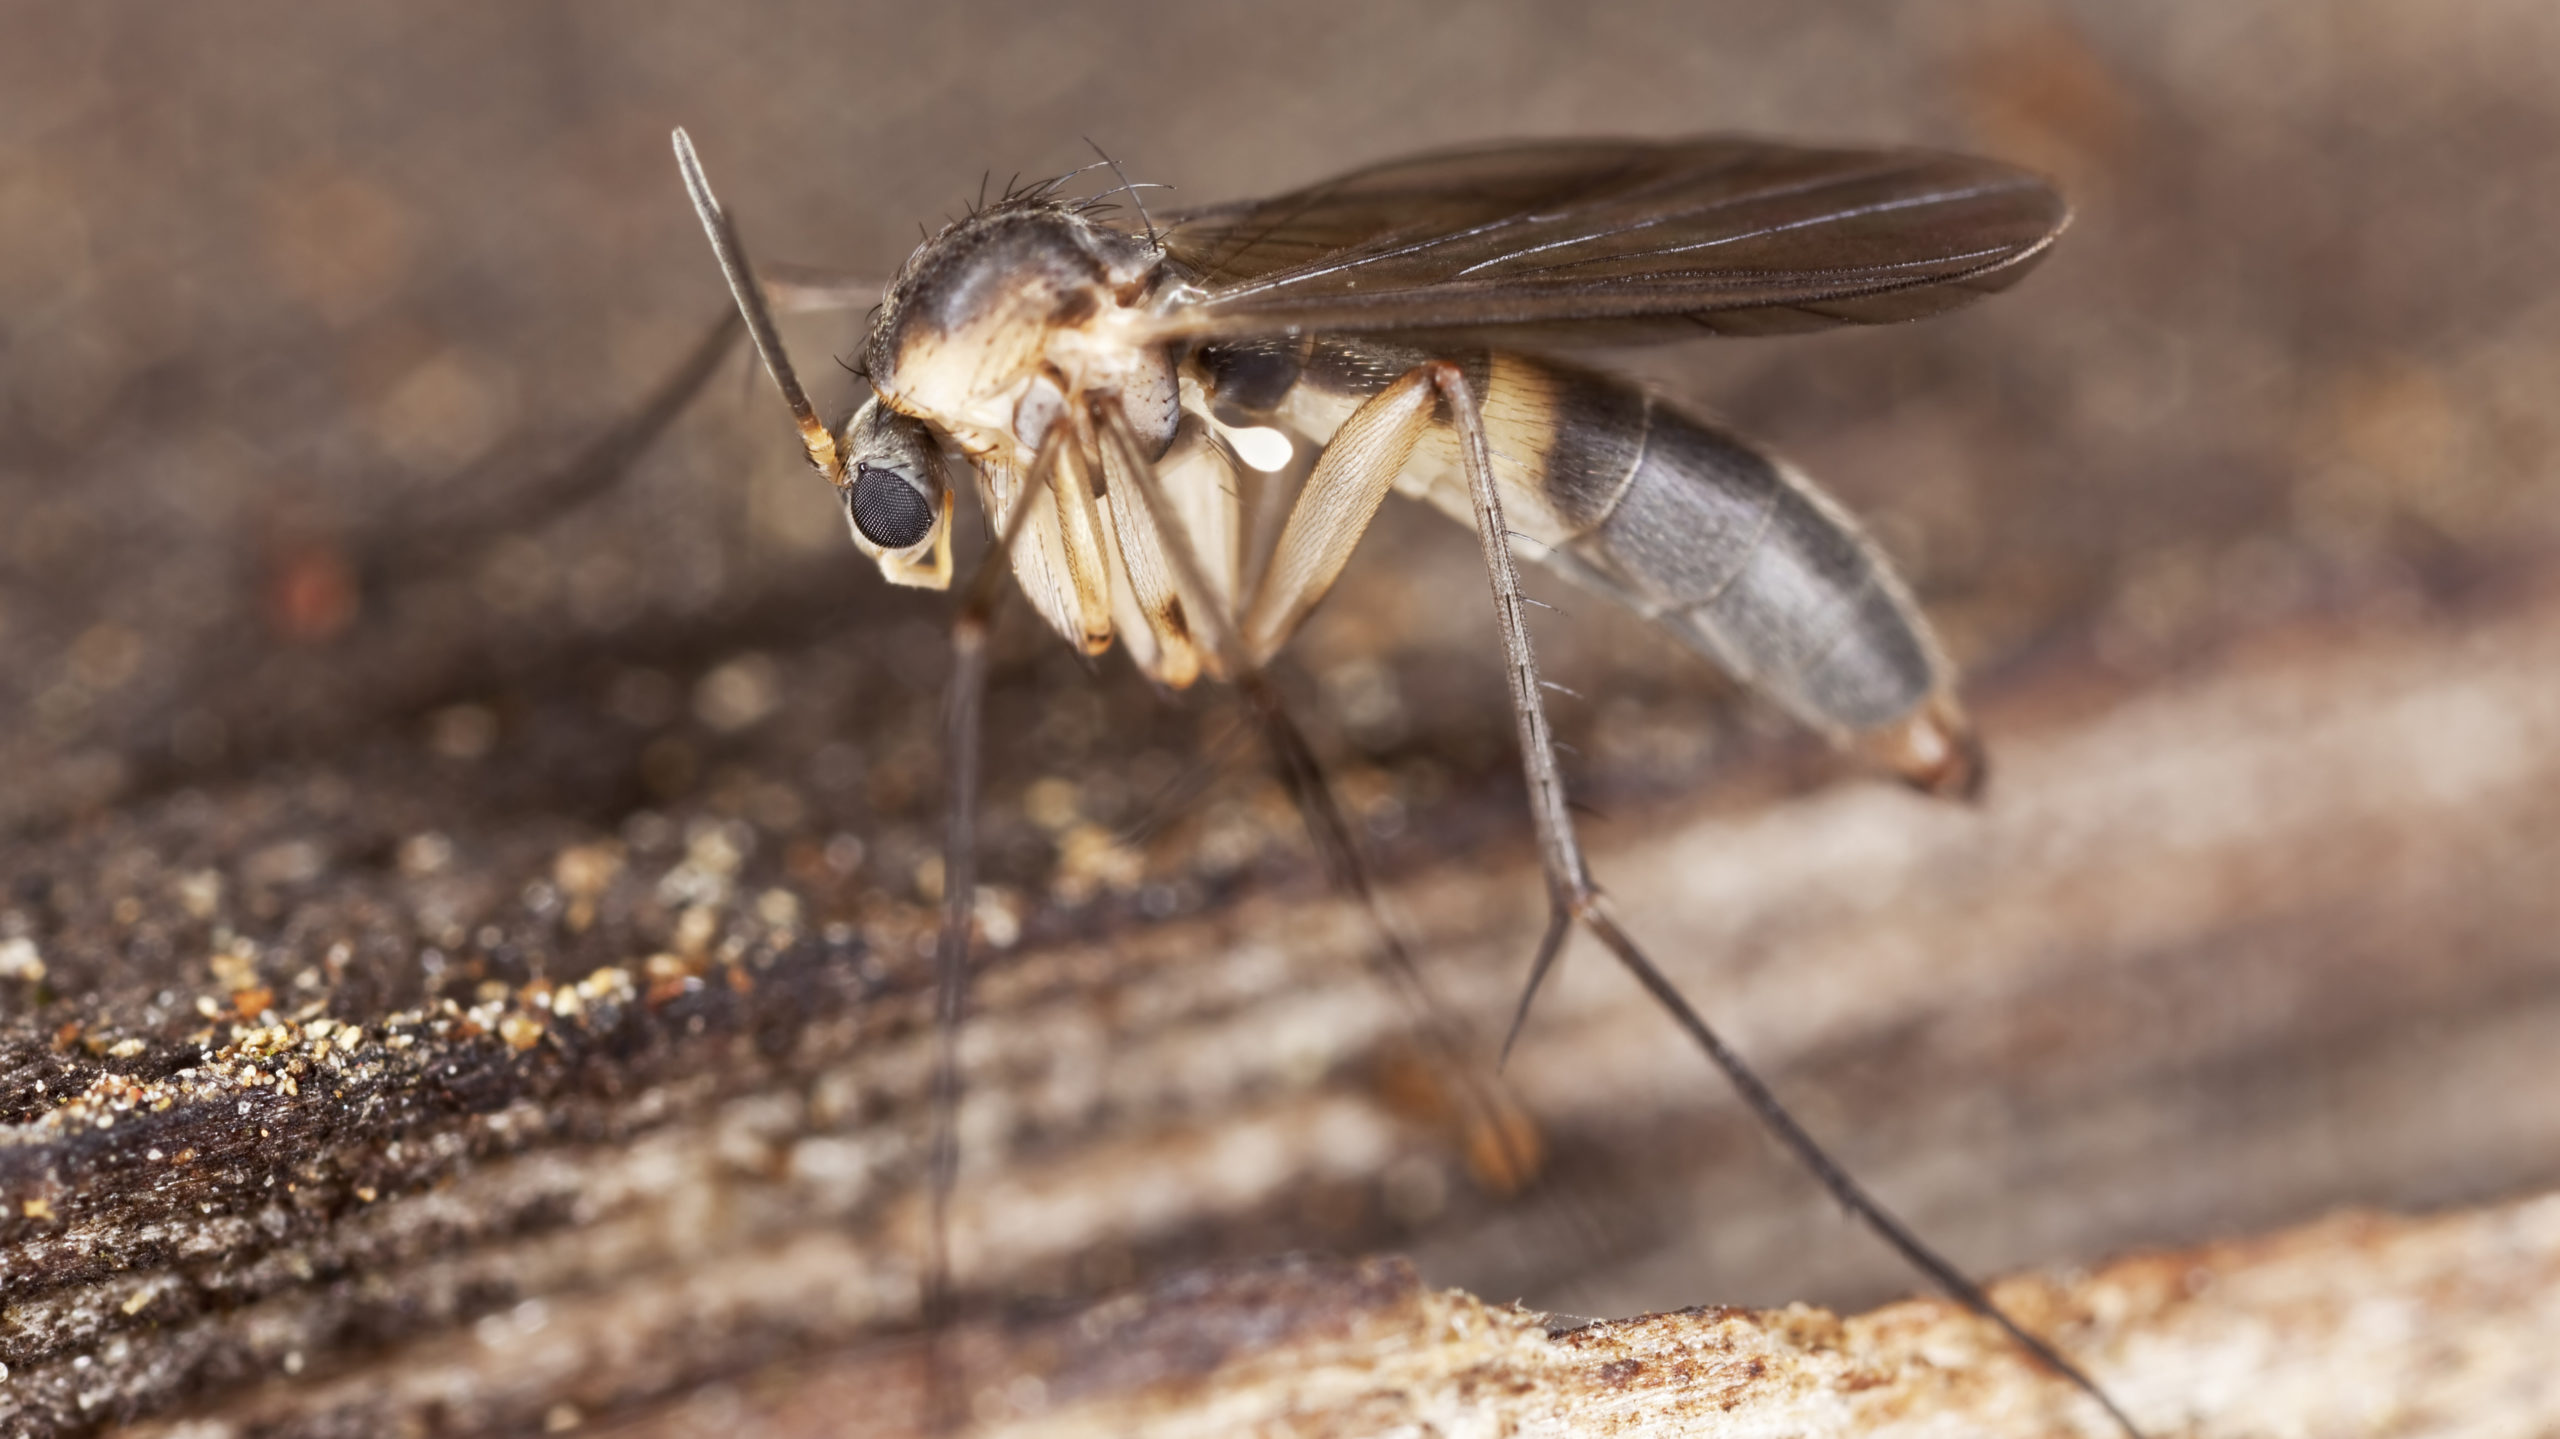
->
924, 425, 1065, 1431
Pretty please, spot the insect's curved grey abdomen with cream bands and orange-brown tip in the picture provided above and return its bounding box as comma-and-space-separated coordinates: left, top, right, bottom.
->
1221, 338, 1979, 791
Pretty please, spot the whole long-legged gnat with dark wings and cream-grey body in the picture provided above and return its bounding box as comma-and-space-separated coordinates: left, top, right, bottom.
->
676, 131, 2135, 1434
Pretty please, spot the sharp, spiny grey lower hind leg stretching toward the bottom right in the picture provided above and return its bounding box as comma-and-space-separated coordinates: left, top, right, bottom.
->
1433, 361, 2140, 1439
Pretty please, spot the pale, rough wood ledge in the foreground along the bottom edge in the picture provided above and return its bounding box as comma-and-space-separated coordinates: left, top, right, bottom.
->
560, 1198, 2560, 1439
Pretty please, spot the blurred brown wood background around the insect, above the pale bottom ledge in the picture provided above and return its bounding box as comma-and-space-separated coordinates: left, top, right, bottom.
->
0, 0, 2560, 1431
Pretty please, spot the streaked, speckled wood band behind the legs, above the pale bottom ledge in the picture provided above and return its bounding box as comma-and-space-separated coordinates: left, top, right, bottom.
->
8, 576, 2560, 1434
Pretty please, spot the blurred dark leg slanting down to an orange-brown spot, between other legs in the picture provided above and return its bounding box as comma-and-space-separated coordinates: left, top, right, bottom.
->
1096, 389, 1541, 1193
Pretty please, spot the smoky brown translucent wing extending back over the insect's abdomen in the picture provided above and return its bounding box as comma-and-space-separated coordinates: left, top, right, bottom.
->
1160, 136, 2071, 346
